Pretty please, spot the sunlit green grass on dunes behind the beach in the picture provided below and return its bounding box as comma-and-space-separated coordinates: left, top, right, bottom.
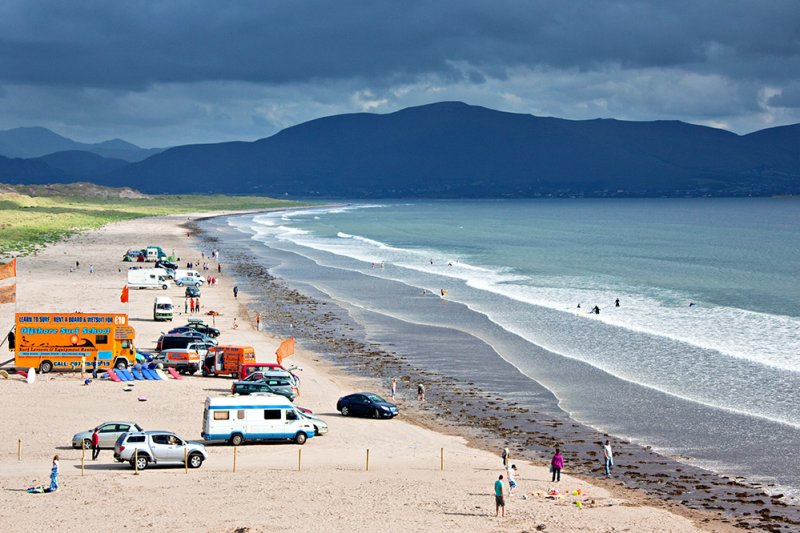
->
0, 192, 307, 256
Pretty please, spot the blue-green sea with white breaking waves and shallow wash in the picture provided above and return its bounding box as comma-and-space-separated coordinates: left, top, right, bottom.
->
202, 198, 800, 503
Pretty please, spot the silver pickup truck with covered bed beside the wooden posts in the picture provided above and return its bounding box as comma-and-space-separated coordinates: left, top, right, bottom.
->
114, 431, 208, 470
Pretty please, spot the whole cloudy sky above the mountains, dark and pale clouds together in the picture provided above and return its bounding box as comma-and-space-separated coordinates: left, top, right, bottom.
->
0, 0, 800, 148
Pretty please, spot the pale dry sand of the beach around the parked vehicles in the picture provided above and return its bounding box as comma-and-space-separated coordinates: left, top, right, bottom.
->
0, 214, 724, 533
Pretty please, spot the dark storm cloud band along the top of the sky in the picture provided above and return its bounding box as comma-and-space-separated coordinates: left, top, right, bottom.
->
0, 0, 800, 89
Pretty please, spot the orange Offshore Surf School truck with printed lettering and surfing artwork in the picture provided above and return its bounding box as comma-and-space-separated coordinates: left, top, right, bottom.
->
8, 313, 136, 374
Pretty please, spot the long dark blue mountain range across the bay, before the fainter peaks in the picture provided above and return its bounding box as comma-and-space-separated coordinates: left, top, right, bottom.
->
0, 102, 800, 198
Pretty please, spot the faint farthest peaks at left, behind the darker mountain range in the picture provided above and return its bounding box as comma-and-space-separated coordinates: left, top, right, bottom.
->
0, 127, 163, 162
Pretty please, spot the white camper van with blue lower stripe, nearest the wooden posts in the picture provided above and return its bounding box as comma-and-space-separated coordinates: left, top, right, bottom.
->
202, 394, 315, 446
